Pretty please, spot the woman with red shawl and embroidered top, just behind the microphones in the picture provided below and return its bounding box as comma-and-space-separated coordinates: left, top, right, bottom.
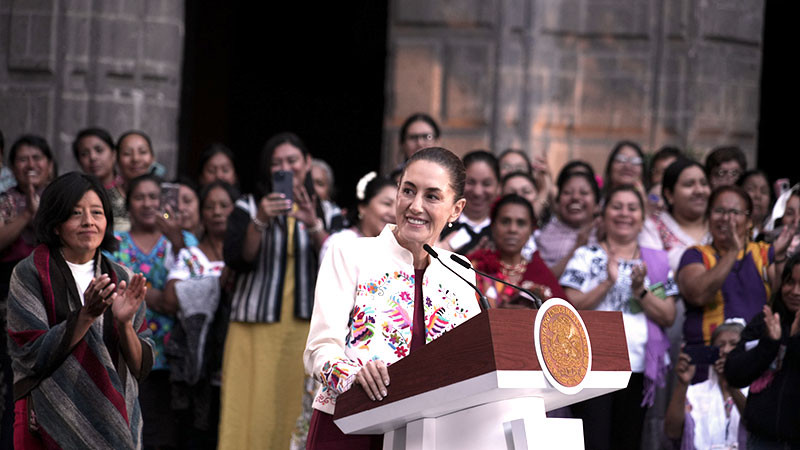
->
468, 194, 566, 308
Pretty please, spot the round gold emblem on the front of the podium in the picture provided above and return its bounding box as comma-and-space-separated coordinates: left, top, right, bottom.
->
538, 304, 590, 388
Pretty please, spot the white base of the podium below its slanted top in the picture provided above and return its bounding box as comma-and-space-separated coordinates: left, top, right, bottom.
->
383, 397, 583, 450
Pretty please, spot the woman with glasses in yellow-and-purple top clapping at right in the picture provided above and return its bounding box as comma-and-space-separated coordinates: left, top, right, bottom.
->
678, 186, 792, 352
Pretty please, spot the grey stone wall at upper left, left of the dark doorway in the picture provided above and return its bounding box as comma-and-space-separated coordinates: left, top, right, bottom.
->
0, 0, 184, 172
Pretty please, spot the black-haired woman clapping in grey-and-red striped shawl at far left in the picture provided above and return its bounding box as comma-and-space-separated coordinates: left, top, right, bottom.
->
8, 172, 153, 449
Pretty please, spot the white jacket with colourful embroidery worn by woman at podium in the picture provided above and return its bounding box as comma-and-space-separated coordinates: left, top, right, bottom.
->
303, 225, 480, 414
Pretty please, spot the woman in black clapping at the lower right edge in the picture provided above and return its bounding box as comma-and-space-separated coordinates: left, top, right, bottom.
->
725, 255, 800, 450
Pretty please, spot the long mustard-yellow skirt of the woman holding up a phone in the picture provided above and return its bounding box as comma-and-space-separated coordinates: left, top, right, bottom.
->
218, 318, 309, 450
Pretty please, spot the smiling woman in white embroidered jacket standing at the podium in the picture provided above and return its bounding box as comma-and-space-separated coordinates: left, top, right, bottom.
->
303, 147, 480, 449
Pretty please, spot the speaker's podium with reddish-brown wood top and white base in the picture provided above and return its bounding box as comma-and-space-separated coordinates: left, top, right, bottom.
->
334, 309, 631, 450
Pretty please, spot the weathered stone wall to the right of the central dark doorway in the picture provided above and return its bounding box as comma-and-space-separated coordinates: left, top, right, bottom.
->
383, 0, 764, 174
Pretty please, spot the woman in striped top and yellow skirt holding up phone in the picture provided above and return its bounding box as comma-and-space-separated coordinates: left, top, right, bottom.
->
219, 133, 338, 449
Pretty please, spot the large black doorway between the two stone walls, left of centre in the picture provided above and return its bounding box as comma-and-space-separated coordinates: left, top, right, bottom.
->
178, 0, 388, 212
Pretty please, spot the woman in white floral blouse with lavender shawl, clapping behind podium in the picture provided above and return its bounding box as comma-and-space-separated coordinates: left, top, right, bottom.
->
561, 185, 678, 449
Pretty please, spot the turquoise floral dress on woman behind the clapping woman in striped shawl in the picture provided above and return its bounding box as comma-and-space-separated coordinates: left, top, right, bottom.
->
108, 231, 197, 370
